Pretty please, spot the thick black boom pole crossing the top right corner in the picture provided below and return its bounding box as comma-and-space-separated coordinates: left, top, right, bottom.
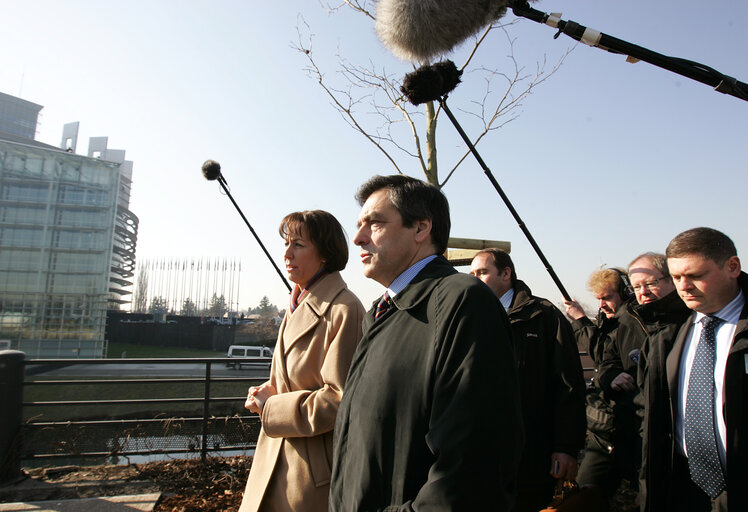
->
509, 0, 748, 101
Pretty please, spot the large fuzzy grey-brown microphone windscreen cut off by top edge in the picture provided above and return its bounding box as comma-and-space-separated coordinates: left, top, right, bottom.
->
375, 0, 512, 62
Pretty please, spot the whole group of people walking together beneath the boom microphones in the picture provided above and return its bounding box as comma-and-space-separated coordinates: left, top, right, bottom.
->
235, 175, 748, 512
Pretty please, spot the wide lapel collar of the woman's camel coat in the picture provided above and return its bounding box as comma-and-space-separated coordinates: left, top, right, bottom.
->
278, 272, 346, 353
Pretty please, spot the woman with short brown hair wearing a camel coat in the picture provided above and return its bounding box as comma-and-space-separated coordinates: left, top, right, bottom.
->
239, 210, 364, 512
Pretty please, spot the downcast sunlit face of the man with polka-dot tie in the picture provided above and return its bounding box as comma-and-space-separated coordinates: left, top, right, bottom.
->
667, 254, 740, 315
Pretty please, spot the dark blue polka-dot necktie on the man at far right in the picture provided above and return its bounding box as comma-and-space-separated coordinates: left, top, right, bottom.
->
685, 316, 725, 498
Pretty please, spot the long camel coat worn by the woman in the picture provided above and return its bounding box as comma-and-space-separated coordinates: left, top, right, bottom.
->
239, 272, 364, 512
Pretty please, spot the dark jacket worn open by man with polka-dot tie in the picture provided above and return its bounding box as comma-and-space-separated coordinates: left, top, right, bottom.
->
639, 273, 748, 512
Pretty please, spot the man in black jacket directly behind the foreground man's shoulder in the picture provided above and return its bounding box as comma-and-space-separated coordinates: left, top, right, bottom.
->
470, 249, 586, 512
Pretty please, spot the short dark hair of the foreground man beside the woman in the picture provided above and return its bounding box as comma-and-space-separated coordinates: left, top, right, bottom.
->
356, 174, 451, 254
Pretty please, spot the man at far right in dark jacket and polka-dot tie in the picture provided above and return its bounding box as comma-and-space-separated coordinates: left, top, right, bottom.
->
640, 228, 748, 512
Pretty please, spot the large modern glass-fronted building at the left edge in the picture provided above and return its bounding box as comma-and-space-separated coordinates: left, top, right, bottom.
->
0, 95, 138, 358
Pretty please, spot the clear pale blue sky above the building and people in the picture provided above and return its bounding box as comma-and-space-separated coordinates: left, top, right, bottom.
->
0, 0, 748, 312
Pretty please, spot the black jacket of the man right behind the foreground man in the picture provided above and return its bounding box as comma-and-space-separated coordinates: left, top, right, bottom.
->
507, 281, 586, 488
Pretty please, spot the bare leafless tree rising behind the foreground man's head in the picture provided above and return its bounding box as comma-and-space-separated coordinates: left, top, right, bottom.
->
293, 0, 571, 187
